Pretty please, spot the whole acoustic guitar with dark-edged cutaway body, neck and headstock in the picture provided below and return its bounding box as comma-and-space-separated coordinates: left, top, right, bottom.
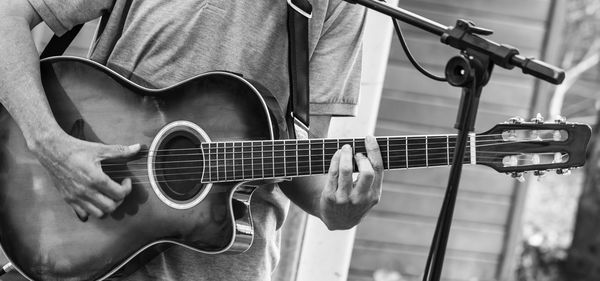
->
0, 57, 591, 280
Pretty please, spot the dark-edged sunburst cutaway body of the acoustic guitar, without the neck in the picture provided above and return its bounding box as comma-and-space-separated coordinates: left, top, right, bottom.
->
0, 57, 277, 280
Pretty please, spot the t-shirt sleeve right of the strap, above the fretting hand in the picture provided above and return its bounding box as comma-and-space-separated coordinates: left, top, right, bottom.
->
309, 1, 366, 116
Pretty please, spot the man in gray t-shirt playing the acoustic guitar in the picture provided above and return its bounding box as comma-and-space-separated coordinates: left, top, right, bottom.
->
0, 0, 383, 280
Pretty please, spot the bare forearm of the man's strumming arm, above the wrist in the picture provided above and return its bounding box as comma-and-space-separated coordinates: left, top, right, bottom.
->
0, 1, 60, 148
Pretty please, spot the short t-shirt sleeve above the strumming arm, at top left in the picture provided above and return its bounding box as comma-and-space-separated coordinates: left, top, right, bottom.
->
28, 0, 113, 36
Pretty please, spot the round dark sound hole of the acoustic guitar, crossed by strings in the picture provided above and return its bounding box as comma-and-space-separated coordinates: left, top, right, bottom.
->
155, 131, 203, 201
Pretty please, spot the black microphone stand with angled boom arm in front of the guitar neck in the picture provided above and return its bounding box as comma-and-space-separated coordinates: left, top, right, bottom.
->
345, 0, 565, 281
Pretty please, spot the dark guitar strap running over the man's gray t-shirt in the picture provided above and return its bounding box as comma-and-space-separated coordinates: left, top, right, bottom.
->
40, 0, 312, 138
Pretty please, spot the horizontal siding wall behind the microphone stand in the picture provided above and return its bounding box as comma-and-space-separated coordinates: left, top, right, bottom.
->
349, 0, 550, 281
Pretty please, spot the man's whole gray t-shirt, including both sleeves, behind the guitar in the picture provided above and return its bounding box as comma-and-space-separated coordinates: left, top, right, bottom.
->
29, 0, 364, 280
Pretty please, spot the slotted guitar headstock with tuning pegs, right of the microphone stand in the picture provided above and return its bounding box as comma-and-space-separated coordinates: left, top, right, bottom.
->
476, 114, 591, 178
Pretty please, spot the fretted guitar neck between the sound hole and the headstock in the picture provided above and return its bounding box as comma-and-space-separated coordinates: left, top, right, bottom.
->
201, 135, 471, 182
